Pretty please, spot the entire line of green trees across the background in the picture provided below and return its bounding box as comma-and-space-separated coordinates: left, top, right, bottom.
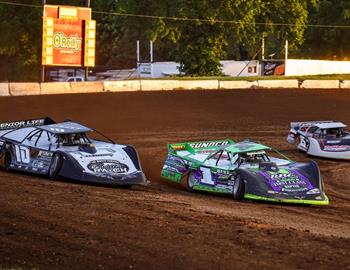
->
0, 0, 350, 81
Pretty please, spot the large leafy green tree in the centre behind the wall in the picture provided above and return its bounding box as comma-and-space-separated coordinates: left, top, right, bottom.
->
119, 0, 315, 76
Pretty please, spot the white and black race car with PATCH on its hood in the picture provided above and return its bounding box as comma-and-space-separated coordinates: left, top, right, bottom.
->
0, 117, 146, 187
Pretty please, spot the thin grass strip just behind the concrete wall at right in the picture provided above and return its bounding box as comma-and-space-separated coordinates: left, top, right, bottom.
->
138, 74, 350, 81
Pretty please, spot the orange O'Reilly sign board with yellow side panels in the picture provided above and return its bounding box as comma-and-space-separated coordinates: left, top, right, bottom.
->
42, 6, 96, 67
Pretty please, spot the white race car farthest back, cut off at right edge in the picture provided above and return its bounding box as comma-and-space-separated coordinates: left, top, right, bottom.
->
287, 121, 350, 160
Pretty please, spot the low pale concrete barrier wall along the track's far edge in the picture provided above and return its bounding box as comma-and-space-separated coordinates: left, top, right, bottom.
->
0, 79, 350, 96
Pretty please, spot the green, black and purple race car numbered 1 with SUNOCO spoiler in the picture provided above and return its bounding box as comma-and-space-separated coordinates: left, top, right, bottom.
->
161, 139, 329, 205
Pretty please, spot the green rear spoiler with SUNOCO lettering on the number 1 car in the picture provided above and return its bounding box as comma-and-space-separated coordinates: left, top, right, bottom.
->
168, 139, 234, 154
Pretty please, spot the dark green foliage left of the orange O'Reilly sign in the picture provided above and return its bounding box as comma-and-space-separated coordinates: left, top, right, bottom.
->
0, 1, 41, 80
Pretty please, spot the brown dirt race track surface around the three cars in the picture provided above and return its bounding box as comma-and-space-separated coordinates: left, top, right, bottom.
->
0, 90, 350, 270
